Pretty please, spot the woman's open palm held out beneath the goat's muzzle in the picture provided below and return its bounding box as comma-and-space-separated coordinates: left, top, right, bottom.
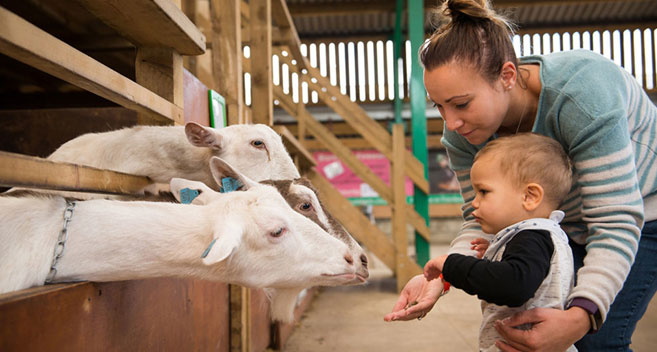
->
383, 275, 443, 321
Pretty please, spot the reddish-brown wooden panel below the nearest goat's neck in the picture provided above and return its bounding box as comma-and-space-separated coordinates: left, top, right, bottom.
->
0, 279, 229, 351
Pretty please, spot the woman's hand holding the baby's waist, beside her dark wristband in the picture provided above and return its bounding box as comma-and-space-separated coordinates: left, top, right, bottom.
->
495, 307, 591, 352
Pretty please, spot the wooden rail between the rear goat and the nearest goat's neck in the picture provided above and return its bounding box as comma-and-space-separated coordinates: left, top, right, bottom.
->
0, 152, 152, 194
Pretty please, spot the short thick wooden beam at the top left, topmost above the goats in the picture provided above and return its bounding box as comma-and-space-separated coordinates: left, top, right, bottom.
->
73, 0, 205, 55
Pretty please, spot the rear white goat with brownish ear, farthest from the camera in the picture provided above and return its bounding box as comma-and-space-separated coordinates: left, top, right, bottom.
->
48, 122, 299, 190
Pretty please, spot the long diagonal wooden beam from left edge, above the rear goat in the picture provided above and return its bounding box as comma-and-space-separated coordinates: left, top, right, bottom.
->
0, 7, 183, 125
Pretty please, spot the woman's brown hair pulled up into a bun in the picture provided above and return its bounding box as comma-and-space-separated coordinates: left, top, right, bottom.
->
419, 0, 518, 82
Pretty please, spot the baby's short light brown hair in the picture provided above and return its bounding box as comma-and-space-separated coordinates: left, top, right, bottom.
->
474, 133, 573, 207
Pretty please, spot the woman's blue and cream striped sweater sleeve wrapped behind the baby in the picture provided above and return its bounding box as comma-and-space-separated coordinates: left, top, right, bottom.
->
544, 53, 644, 318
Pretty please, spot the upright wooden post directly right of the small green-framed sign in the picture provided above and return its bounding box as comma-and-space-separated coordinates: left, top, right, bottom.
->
210, 0, 245, 125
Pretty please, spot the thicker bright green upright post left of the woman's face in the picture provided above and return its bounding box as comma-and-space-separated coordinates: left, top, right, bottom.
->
408, 0, 430, 266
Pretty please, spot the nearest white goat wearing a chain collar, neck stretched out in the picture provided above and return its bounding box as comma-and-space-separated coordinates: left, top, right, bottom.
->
0, 158, 355, 314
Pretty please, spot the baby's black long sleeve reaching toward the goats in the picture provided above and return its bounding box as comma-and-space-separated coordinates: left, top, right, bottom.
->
443, 230, 554, 307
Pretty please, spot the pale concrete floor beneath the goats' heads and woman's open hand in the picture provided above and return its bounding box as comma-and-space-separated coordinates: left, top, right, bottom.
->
283, 246, 657, 352
